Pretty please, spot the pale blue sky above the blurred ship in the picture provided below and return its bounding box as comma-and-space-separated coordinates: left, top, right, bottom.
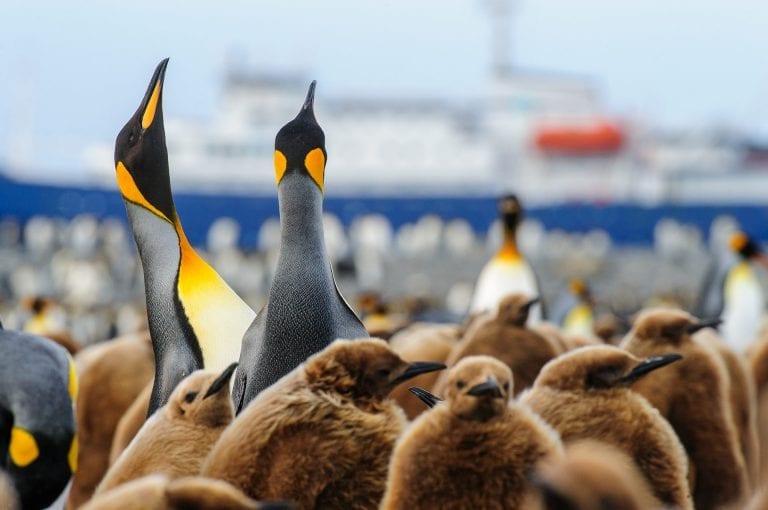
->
0, 0, 768, 174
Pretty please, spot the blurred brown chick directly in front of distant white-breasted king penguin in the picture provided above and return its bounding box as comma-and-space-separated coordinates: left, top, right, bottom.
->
434, 294, 560, 395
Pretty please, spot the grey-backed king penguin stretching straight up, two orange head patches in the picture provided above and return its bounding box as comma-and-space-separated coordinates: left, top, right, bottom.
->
232, 81, 368, 413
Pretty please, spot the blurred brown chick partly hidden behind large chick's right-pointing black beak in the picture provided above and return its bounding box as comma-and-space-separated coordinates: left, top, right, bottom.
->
389, 323, 459, 420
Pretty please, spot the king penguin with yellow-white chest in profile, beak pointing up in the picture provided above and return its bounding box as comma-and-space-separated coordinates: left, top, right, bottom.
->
115, 59, 255, 415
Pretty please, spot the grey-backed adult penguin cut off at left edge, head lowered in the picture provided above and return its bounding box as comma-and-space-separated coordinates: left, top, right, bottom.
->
0, 329, 77, 509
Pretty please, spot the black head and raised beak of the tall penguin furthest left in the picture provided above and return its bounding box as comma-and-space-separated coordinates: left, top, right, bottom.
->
115, 58, 176, 221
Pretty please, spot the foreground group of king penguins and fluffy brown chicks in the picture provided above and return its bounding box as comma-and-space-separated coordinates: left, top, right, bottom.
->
7, 59, 768, 510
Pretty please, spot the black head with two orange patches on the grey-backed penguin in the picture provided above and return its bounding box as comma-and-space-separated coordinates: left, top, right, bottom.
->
275, 81, 328, 191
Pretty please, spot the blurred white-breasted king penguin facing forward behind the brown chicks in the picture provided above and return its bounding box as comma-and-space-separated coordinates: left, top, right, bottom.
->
469, 195, 543, 324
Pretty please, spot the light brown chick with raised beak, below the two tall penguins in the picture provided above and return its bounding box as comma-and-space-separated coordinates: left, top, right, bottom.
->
96, 363, 237, 493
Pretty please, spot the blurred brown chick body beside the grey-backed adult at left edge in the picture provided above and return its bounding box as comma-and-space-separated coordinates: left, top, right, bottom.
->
68, 333, 155, 508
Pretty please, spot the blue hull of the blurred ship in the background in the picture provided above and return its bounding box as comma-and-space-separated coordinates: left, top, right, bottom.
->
0, 174, 768, 249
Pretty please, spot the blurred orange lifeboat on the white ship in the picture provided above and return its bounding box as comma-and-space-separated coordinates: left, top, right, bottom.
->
534, 121, 625, 156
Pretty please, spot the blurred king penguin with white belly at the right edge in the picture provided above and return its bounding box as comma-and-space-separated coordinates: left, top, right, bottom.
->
696, 232, 768, 352
